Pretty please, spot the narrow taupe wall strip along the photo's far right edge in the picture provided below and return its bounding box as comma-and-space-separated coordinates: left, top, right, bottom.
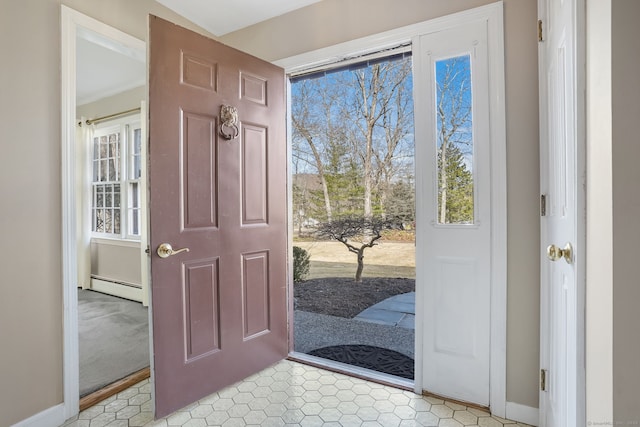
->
611, 0, 640, 425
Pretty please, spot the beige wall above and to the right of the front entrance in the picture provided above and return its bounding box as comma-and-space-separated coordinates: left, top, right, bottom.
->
220, 0, 540, 407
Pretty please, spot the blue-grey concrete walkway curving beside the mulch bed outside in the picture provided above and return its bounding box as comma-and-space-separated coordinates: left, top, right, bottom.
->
353, 292, 416, 329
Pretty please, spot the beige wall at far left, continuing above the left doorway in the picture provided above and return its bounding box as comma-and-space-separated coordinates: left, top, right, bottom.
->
0, 0, 210, 426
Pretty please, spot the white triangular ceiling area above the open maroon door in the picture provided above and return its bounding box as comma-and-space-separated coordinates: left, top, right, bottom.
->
157, 0, 320, 36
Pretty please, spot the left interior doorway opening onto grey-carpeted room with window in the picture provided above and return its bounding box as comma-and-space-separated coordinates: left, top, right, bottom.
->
62, 6, 150, 416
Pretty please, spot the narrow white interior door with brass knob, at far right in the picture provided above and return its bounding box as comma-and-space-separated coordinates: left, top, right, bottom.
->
539, 0, 583, 427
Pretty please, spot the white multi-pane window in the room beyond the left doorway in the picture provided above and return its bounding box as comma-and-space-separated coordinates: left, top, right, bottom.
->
91, 121, 141, 239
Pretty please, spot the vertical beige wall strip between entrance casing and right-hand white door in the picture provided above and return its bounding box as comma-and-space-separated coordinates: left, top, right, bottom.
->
504, 0, 540, 408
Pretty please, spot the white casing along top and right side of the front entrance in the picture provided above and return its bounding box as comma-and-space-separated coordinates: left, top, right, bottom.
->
275, 1, 507, 417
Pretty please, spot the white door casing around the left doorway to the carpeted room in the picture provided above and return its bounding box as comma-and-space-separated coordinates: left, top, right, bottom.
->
61, 5, 146, 420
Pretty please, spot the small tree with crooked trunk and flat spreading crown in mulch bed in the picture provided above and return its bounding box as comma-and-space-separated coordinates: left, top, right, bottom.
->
317, 216, 398, 282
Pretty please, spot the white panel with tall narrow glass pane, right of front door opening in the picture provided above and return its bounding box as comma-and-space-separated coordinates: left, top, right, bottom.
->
413, 21, 492, 406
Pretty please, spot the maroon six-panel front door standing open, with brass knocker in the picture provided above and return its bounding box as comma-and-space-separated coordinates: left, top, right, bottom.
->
149, 16, 287, 417
